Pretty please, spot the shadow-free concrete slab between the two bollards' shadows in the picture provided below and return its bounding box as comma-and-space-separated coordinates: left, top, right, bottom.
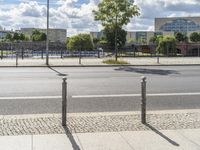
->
77, 132, 134, 150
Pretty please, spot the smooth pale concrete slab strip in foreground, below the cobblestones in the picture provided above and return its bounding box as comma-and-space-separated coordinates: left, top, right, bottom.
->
0, 129, 200, 150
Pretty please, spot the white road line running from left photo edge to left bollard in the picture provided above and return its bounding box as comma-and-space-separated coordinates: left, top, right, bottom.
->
0, 96, 61, 100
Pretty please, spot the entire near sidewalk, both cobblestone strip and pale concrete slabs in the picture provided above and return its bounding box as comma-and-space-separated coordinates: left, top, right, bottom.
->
0, 109, 200, 150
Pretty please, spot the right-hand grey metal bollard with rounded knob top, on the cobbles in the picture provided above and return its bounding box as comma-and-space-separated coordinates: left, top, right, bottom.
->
141, 76, 146, 124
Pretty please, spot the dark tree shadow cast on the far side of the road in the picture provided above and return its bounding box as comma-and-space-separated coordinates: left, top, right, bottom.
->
114, 66, 179, 75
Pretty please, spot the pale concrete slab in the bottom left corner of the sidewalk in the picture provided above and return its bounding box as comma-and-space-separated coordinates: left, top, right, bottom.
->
0, 135, 32, 150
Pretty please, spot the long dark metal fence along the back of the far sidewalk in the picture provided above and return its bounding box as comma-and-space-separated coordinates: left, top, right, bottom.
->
0, 42, 200, 59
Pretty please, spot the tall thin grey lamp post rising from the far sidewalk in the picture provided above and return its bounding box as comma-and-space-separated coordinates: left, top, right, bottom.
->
46, 0, 49, 65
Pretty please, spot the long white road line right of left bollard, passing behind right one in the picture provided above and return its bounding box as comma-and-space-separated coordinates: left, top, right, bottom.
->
72, 92, 200, 98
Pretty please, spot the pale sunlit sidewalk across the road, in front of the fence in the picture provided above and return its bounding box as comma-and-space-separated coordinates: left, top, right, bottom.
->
0, 57, 200, 67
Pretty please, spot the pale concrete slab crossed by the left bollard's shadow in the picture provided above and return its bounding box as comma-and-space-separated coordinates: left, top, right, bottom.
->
33, 134, 81, 150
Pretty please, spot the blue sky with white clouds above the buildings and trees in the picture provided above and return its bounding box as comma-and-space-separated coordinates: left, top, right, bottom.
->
0, 0, 200, 36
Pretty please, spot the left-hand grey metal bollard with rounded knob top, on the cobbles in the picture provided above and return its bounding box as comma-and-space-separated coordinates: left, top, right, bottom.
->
62, 77, 67, 126
